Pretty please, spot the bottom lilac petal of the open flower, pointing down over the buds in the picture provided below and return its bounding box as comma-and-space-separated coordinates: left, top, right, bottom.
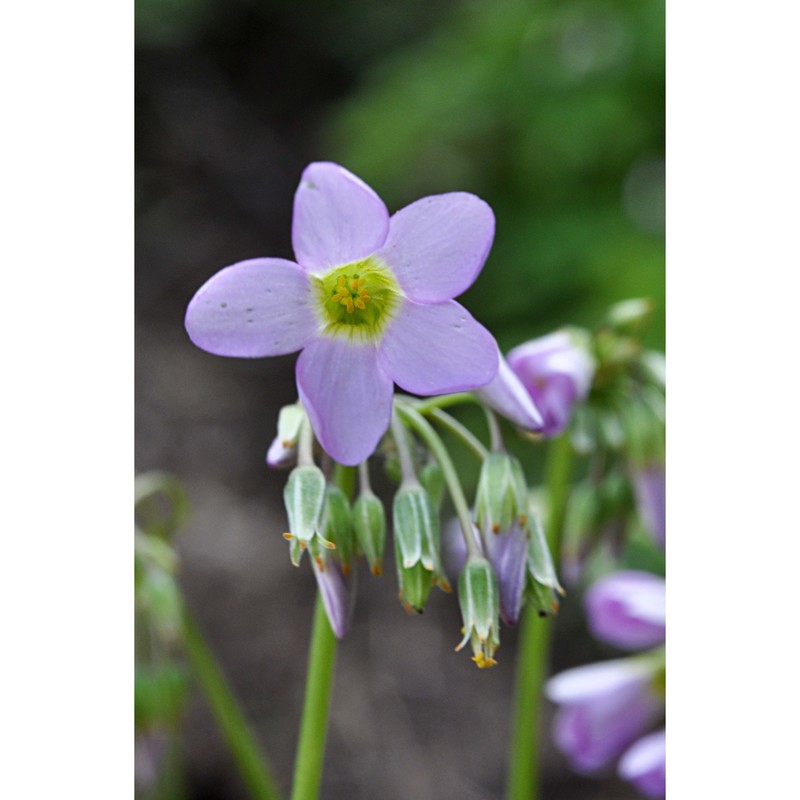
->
296, 339, 392, 466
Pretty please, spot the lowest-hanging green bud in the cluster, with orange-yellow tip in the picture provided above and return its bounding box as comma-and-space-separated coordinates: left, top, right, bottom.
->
456, 556, 500, 669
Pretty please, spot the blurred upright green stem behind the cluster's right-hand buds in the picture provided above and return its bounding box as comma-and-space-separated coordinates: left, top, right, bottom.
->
507, 434, 572, 800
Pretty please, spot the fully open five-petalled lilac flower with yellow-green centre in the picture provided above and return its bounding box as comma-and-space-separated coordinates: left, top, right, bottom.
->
186, 162, 498, 465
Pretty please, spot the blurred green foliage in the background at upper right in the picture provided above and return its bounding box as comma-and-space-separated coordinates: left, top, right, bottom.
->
326, 0, 665, 349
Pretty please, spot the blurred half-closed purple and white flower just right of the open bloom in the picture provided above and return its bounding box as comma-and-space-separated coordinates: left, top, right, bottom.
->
506, 331, 594, 437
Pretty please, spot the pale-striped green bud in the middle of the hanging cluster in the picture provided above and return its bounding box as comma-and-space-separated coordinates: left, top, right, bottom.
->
392, 483, 450, 612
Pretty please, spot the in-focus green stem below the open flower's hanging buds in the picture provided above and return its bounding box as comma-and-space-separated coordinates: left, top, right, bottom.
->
292, 593, 336, 800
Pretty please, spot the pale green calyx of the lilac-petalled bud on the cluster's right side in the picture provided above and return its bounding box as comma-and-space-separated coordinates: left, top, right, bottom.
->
475, 453, 528, 535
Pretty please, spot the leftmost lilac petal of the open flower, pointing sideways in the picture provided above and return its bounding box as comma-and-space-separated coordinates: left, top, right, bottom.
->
185, 258, 318, 358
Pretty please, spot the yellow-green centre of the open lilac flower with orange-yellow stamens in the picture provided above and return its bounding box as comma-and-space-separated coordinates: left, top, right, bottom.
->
314, 257, 403, 341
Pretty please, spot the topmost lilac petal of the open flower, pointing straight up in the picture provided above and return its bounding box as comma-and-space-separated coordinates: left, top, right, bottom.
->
292, 162, 389, 270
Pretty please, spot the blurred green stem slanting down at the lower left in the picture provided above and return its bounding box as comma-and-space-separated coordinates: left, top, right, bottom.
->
183, 610, 280, 800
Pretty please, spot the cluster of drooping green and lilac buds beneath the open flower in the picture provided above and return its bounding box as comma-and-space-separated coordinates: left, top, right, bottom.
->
270, 401, 563, 668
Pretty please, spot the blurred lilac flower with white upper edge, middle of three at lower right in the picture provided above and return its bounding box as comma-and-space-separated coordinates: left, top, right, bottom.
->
545, 656, 664, 772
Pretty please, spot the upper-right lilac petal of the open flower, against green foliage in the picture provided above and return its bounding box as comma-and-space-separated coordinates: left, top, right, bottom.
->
376, 192, 494, 303
